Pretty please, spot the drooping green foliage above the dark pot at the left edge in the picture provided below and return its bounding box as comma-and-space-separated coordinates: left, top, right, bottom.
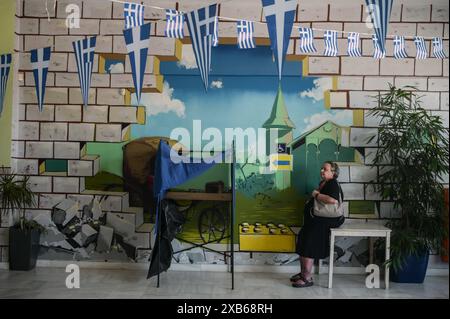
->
0, 173, 43, 231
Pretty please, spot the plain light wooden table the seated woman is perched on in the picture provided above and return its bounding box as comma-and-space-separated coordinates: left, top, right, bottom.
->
328, 222, 391, 289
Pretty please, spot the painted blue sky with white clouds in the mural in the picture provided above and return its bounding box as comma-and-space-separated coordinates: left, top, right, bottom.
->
132, 45, 352, 145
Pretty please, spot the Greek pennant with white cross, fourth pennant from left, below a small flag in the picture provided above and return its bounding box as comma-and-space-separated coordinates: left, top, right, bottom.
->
123, 23, 150, 105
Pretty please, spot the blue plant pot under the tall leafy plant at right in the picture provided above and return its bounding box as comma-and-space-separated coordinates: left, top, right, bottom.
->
390, 251, 430, 284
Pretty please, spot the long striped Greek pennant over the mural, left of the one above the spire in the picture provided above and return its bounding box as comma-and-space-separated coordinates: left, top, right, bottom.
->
186, 4, 217, 90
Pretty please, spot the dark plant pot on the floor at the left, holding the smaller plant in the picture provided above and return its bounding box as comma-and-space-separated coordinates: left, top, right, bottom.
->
9, 227, 40, 270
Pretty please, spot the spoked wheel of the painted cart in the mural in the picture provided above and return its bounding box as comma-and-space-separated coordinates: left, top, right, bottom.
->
198, 207, 227, 243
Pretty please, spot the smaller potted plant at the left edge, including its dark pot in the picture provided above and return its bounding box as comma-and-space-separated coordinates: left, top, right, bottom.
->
0, 173, 45, 270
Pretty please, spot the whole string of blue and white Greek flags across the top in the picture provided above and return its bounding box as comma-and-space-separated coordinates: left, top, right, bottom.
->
0, 0, 447, 115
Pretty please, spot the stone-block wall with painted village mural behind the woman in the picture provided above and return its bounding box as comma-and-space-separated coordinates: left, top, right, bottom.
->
0, 0, 448, 266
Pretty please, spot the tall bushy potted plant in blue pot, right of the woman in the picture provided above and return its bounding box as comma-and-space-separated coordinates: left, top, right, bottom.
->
370, 85, 449, 283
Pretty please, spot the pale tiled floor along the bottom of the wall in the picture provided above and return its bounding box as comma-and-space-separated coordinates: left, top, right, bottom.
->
0, 268, 449, 299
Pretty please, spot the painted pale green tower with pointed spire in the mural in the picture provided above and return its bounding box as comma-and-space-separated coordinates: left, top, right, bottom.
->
263, 85, 295, 190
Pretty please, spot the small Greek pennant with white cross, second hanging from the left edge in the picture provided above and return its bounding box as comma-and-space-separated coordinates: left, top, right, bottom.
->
31, 47, 52, 112
